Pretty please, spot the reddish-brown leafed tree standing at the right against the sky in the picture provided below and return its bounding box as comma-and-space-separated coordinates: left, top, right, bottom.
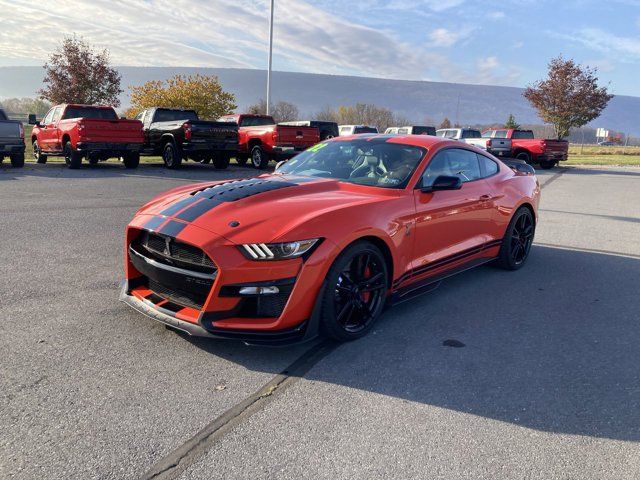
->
523, 56, 613, 139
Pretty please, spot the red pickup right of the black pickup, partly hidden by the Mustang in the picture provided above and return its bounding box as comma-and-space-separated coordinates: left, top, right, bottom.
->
219, 113, 320, 169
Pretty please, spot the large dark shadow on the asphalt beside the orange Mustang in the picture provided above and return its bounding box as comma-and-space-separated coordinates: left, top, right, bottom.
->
189, 246, 640, 441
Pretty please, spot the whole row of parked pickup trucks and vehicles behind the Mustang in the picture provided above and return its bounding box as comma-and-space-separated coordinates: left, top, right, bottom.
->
0, 104, 568, 169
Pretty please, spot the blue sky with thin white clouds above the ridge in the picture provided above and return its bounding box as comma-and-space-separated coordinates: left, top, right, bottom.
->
0, 0, 640, 96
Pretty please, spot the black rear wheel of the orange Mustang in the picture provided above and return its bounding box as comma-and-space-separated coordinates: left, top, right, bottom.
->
497, 207, 536, 270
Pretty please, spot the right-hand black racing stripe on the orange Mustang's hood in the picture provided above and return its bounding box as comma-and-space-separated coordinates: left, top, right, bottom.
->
176, 178, 298, 222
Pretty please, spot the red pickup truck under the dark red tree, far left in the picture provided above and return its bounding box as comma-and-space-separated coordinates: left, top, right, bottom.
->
31, 104, 144, 168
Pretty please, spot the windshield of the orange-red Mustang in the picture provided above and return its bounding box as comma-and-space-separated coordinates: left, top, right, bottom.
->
276, 139, 427, 188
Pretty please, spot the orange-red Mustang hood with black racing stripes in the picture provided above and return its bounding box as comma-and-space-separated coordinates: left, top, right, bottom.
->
138, 175, 389, 244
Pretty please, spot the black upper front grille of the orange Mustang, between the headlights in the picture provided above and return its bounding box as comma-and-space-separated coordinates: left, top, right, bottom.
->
134, 231, 217, 273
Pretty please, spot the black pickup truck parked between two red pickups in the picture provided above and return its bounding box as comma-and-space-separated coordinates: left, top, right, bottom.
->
136, 107, 238, 168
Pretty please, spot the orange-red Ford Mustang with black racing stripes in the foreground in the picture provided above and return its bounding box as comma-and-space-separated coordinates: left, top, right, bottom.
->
121, 135, 540, 343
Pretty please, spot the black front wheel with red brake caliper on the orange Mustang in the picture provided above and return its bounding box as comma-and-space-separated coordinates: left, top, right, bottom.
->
319, 241, 389, 341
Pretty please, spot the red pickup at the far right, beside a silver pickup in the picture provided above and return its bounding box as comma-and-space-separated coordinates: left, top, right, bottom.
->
482, 128, 569, 169
